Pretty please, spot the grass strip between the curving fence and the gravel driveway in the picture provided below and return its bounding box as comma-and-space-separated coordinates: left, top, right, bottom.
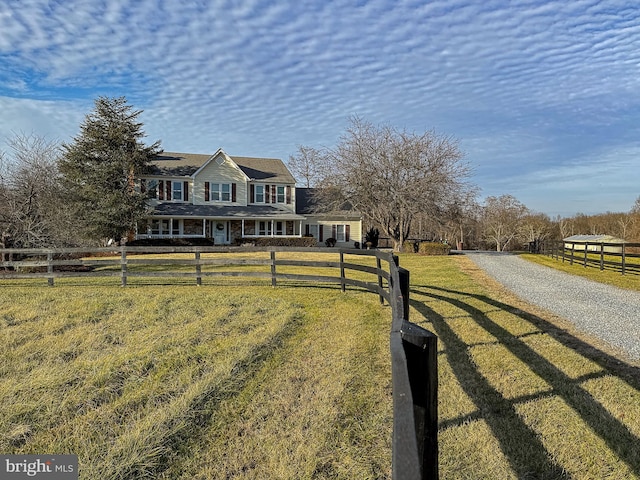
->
401, 256, 640, 479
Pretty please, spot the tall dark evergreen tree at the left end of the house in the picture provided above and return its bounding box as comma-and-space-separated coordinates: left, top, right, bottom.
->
59, 97, 161, 241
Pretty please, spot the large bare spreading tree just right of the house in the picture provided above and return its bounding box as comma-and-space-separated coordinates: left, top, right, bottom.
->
312, 118, 473, 251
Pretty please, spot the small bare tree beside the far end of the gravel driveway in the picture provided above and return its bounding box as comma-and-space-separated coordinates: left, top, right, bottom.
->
482, 195, 529, 252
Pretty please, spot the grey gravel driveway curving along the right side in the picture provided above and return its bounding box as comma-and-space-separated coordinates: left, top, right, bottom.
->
464, 251, 640, 360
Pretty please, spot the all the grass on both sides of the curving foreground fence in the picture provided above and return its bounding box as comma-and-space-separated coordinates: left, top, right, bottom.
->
0, 255, 640, 479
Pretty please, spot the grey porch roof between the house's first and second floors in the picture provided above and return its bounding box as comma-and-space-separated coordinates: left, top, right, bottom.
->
153, 202, 304, 220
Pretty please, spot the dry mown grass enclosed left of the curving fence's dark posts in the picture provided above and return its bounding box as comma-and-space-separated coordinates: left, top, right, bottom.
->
0, 285, 391, 479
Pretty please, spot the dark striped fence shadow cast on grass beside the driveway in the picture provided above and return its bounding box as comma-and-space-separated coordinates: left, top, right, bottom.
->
411, 286, 640, 478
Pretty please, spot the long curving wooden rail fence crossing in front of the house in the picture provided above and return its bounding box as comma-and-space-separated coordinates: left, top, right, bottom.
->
0, 247, 438, 480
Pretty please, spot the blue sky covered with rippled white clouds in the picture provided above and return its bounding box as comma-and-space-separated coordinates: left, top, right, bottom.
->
0, 0, 640, 216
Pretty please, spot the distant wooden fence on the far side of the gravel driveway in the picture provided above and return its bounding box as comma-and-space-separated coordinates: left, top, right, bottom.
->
540, 240, 640, 275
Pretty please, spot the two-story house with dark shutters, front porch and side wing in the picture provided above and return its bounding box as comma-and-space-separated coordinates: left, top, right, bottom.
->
136, 149, 361, 245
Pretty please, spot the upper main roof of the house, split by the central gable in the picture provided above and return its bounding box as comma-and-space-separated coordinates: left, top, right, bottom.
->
150, 152, 296, 183
